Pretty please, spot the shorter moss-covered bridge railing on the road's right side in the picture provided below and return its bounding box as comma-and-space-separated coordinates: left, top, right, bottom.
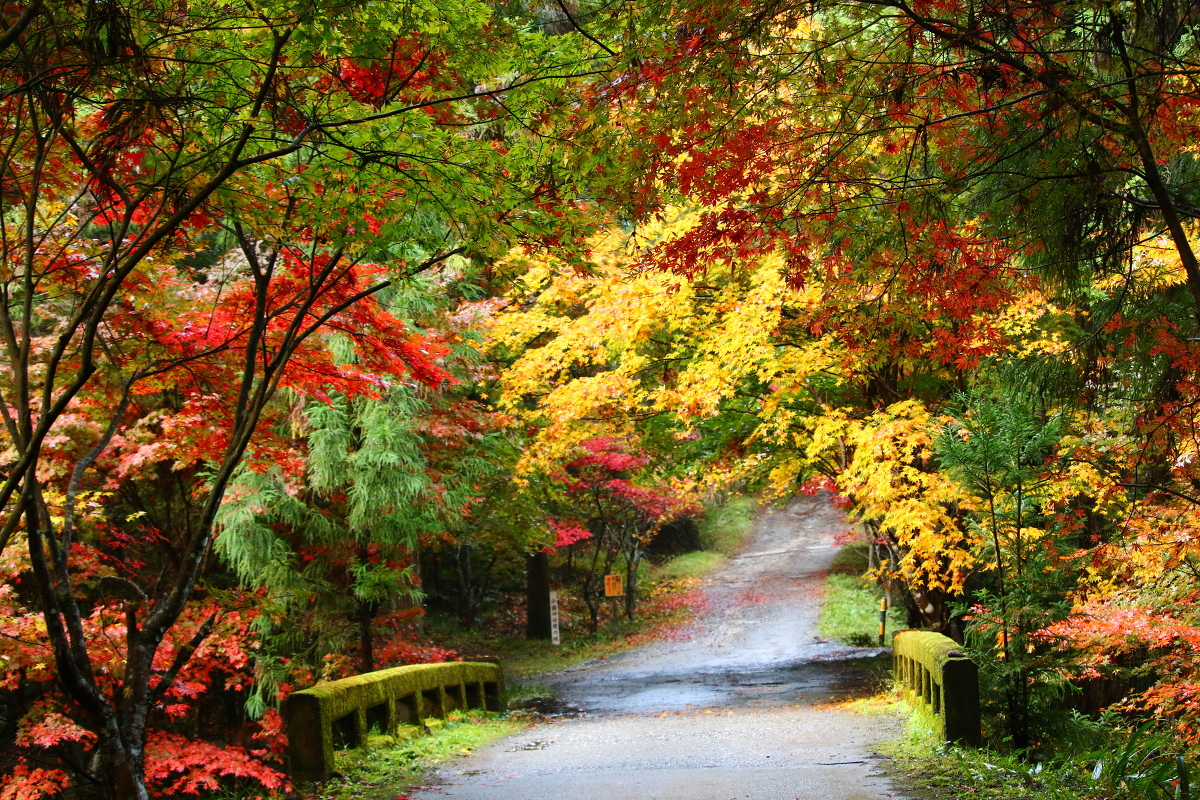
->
892, 631, 980, 747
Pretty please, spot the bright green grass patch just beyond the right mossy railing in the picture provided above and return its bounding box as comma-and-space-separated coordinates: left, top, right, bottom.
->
817, 545, 905, 648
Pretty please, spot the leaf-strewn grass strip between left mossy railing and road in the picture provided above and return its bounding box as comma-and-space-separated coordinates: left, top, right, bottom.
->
296, 711, 524, 800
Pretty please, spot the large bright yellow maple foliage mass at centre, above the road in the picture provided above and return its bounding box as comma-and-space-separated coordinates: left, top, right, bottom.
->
487, 212, 841, 482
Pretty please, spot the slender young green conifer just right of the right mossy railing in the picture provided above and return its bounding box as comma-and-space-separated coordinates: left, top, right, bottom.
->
936, 392, 1076, 751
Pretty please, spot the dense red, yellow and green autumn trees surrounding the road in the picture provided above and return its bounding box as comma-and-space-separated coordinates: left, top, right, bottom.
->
0, 0, 1200, 800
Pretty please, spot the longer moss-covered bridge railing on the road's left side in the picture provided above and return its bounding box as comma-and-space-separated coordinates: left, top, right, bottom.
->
283, 661, 504, 782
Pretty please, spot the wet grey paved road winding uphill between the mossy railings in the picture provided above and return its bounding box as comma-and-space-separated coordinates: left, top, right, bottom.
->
413, 497, 900, 800
